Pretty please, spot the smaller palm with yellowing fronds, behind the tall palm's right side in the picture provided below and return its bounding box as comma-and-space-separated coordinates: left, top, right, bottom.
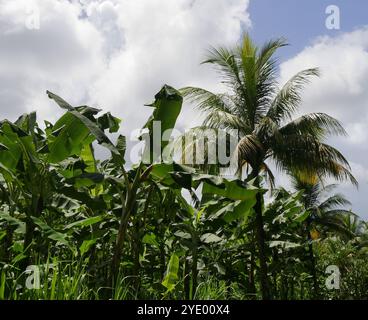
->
291, 173, 357, 298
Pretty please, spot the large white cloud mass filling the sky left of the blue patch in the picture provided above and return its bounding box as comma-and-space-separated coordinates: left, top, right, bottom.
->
0, 0, 250, 133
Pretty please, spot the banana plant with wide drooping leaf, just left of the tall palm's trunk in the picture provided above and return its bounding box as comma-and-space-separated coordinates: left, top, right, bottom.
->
150, 163, 264, 299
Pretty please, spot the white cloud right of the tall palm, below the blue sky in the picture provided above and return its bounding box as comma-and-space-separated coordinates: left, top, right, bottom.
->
281, 28, 368, 124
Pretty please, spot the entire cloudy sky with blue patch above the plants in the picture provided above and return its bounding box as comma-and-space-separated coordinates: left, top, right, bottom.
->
0, 0, 368, 219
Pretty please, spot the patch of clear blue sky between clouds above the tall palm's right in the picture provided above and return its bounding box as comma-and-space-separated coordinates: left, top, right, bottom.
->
248, 0, 368, 61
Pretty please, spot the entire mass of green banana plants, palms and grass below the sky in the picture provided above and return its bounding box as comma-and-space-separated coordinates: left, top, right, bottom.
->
0, 37, 368, 300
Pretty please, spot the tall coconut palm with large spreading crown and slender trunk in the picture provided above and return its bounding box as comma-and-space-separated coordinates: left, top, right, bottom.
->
181, 34, 356, 299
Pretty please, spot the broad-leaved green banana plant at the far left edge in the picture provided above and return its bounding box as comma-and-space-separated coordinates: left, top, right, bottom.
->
0, 92, 119, 264
